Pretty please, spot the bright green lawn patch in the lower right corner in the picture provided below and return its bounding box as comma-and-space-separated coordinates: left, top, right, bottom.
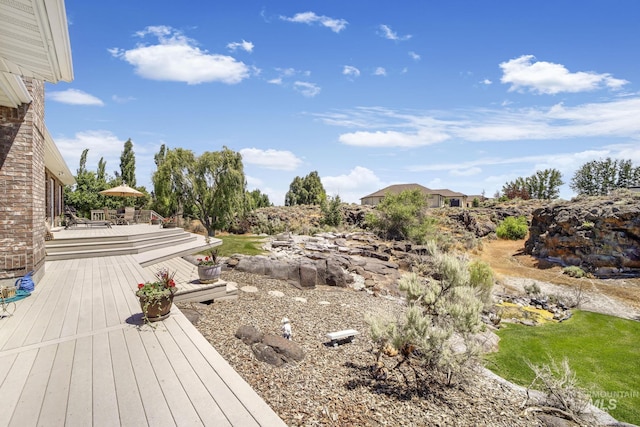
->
486, 311, 640, 424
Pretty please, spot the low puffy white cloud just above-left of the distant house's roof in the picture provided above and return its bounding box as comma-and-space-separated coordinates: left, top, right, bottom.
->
320, 166, 386, 203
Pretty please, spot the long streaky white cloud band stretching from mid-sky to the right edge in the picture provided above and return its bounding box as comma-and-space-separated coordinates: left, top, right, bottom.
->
317, 97, 640, 147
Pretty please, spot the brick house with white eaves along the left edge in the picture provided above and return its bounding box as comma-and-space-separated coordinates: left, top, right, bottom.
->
0, 0, 75, 288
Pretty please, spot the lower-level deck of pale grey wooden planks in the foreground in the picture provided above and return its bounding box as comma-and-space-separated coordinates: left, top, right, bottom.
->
0, 255, 284, 427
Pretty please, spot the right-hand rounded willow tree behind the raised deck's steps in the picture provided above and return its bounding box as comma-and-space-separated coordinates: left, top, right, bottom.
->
184, 147, 246, 236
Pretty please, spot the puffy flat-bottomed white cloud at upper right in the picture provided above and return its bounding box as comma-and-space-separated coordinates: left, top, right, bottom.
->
500, 55, 628, 95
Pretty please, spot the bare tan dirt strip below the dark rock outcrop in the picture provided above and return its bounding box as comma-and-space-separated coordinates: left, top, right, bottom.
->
475, 240, 640, 320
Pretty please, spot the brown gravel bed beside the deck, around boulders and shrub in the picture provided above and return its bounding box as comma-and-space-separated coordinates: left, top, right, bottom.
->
179, 271, 541, 426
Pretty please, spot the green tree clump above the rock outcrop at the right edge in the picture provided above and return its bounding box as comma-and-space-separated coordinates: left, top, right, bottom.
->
570, 157, 640, 196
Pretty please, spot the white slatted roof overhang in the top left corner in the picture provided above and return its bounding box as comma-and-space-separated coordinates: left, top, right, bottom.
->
0, 0, 73, 108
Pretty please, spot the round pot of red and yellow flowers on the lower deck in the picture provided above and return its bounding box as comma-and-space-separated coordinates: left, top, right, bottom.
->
136, 269, 176, 323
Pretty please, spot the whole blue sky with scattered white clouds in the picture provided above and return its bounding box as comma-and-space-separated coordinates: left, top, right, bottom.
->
46, 0, 640, 205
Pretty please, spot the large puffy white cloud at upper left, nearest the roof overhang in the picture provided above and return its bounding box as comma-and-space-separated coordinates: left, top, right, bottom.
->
109, 26, 250, 85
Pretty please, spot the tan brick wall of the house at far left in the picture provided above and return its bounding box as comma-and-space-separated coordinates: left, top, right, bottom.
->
0, 79, 46, 280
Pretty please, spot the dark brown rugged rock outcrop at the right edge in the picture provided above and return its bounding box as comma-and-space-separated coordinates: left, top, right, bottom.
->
525, 194, 640, 277
